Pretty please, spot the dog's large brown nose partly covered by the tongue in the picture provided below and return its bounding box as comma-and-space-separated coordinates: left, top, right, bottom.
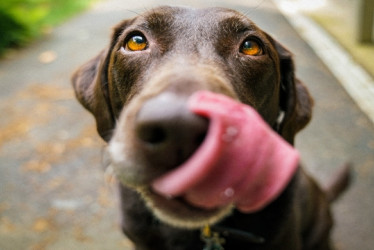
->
136, 93, 209, 171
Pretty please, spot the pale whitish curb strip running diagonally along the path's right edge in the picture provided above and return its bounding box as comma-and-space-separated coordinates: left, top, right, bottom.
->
273, 0, 374, 123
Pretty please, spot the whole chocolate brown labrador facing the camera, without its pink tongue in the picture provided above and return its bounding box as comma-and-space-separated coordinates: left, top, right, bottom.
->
72, 7, 348, 250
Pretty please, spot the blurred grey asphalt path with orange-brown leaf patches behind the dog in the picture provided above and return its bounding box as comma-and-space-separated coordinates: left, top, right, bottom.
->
0, 0, 374, 250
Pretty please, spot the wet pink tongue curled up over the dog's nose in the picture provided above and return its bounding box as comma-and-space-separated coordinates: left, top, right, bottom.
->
152, 91, 299, 213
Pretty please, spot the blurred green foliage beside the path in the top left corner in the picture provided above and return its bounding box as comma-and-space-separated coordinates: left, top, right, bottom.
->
0, 0, 94, 54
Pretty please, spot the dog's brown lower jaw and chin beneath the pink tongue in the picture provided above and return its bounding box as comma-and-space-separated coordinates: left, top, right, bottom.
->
137, 187, 233, 229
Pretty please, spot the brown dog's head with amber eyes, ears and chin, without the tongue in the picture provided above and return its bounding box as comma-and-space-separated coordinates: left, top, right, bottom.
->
73, 7, 311, 227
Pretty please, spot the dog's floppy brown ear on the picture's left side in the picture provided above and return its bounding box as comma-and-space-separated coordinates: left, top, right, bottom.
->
71, 20, 129, 142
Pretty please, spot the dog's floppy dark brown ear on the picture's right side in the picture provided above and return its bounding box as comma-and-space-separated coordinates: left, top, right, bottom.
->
274, 41, 313, 144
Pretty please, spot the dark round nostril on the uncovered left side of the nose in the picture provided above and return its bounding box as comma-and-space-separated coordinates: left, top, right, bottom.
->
136, 124, 167, 145
